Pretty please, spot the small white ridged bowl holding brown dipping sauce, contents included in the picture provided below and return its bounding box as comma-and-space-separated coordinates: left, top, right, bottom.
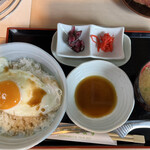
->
67, 60, 134, 133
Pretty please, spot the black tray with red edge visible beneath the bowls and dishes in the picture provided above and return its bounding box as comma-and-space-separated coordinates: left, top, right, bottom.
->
7, 28, 150, 146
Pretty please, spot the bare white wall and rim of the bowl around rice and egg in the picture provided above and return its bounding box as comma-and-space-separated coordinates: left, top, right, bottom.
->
0, 42, 67, 149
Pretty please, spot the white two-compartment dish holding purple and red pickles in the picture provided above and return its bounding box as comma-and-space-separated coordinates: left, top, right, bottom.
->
56, 23, 125, 59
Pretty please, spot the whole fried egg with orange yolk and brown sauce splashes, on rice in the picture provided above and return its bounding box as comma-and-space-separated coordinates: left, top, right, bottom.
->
0, 58, 61, 116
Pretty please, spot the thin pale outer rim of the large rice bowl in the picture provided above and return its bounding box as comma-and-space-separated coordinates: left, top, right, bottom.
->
0, 42, 67, 149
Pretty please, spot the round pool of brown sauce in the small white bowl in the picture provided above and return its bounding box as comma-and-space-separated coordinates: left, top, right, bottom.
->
75, 76, 117, 118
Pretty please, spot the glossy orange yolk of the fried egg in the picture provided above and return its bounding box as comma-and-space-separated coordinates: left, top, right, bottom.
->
0, 80, 21, 109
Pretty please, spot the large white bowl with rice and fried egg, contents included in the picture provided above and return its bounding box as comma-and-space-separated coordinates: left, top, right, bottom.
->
0, 42, 67, 150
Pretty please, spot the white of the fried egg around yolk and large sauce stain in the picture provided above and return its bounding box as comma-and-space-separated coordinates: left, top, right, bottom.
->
0, 58, 60, 116
